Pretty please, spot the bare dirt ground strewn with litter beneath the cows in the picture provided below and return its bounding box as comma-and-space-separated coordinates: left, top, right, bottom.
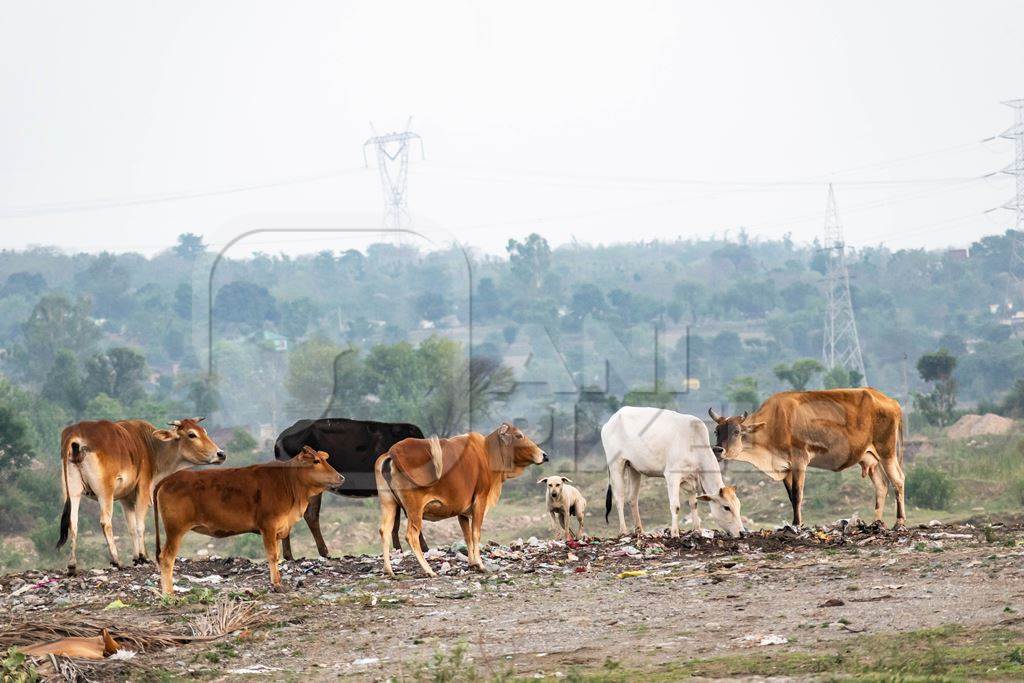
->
0, 520, 1024, 680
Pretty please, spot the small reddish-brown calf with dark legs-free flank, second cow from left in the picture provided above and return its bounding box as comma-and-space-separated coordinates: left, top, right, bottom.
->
153, 445, 345, 595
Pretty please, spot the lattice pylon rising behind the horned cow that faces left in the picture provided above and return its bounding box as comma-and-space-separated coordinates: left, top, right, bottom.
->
821, 183, 867, 384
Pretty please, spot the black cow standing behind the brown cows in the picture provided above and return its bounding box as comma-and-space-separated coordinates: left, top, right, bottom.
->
273, 418, 426, 560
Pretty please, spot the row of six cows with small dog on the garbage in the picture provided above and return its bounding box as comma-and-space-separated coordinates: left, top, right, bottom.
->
57, 388, 905, 594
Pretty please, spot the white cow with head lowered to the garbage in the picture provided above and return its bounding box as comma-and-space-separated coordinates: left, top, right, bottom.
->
601, 407, 743, 537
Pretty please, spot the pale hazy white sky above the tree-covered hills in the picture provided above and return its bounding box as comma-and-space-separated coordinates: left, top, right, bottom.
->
0, 0, 1024, 253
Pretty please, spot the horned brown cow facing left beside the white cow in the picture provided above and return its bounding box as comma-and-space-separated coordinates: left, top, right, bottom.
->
708, 387, 906, 526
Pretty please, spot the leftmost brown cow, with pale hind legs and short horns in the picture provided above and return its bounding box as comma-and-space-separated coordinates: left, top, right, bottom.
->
57, 418, 224, 574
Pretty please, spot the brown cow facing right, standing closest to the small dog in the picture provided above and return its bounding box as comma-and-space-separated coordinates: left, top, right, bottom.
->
374, 423, 548, 577
